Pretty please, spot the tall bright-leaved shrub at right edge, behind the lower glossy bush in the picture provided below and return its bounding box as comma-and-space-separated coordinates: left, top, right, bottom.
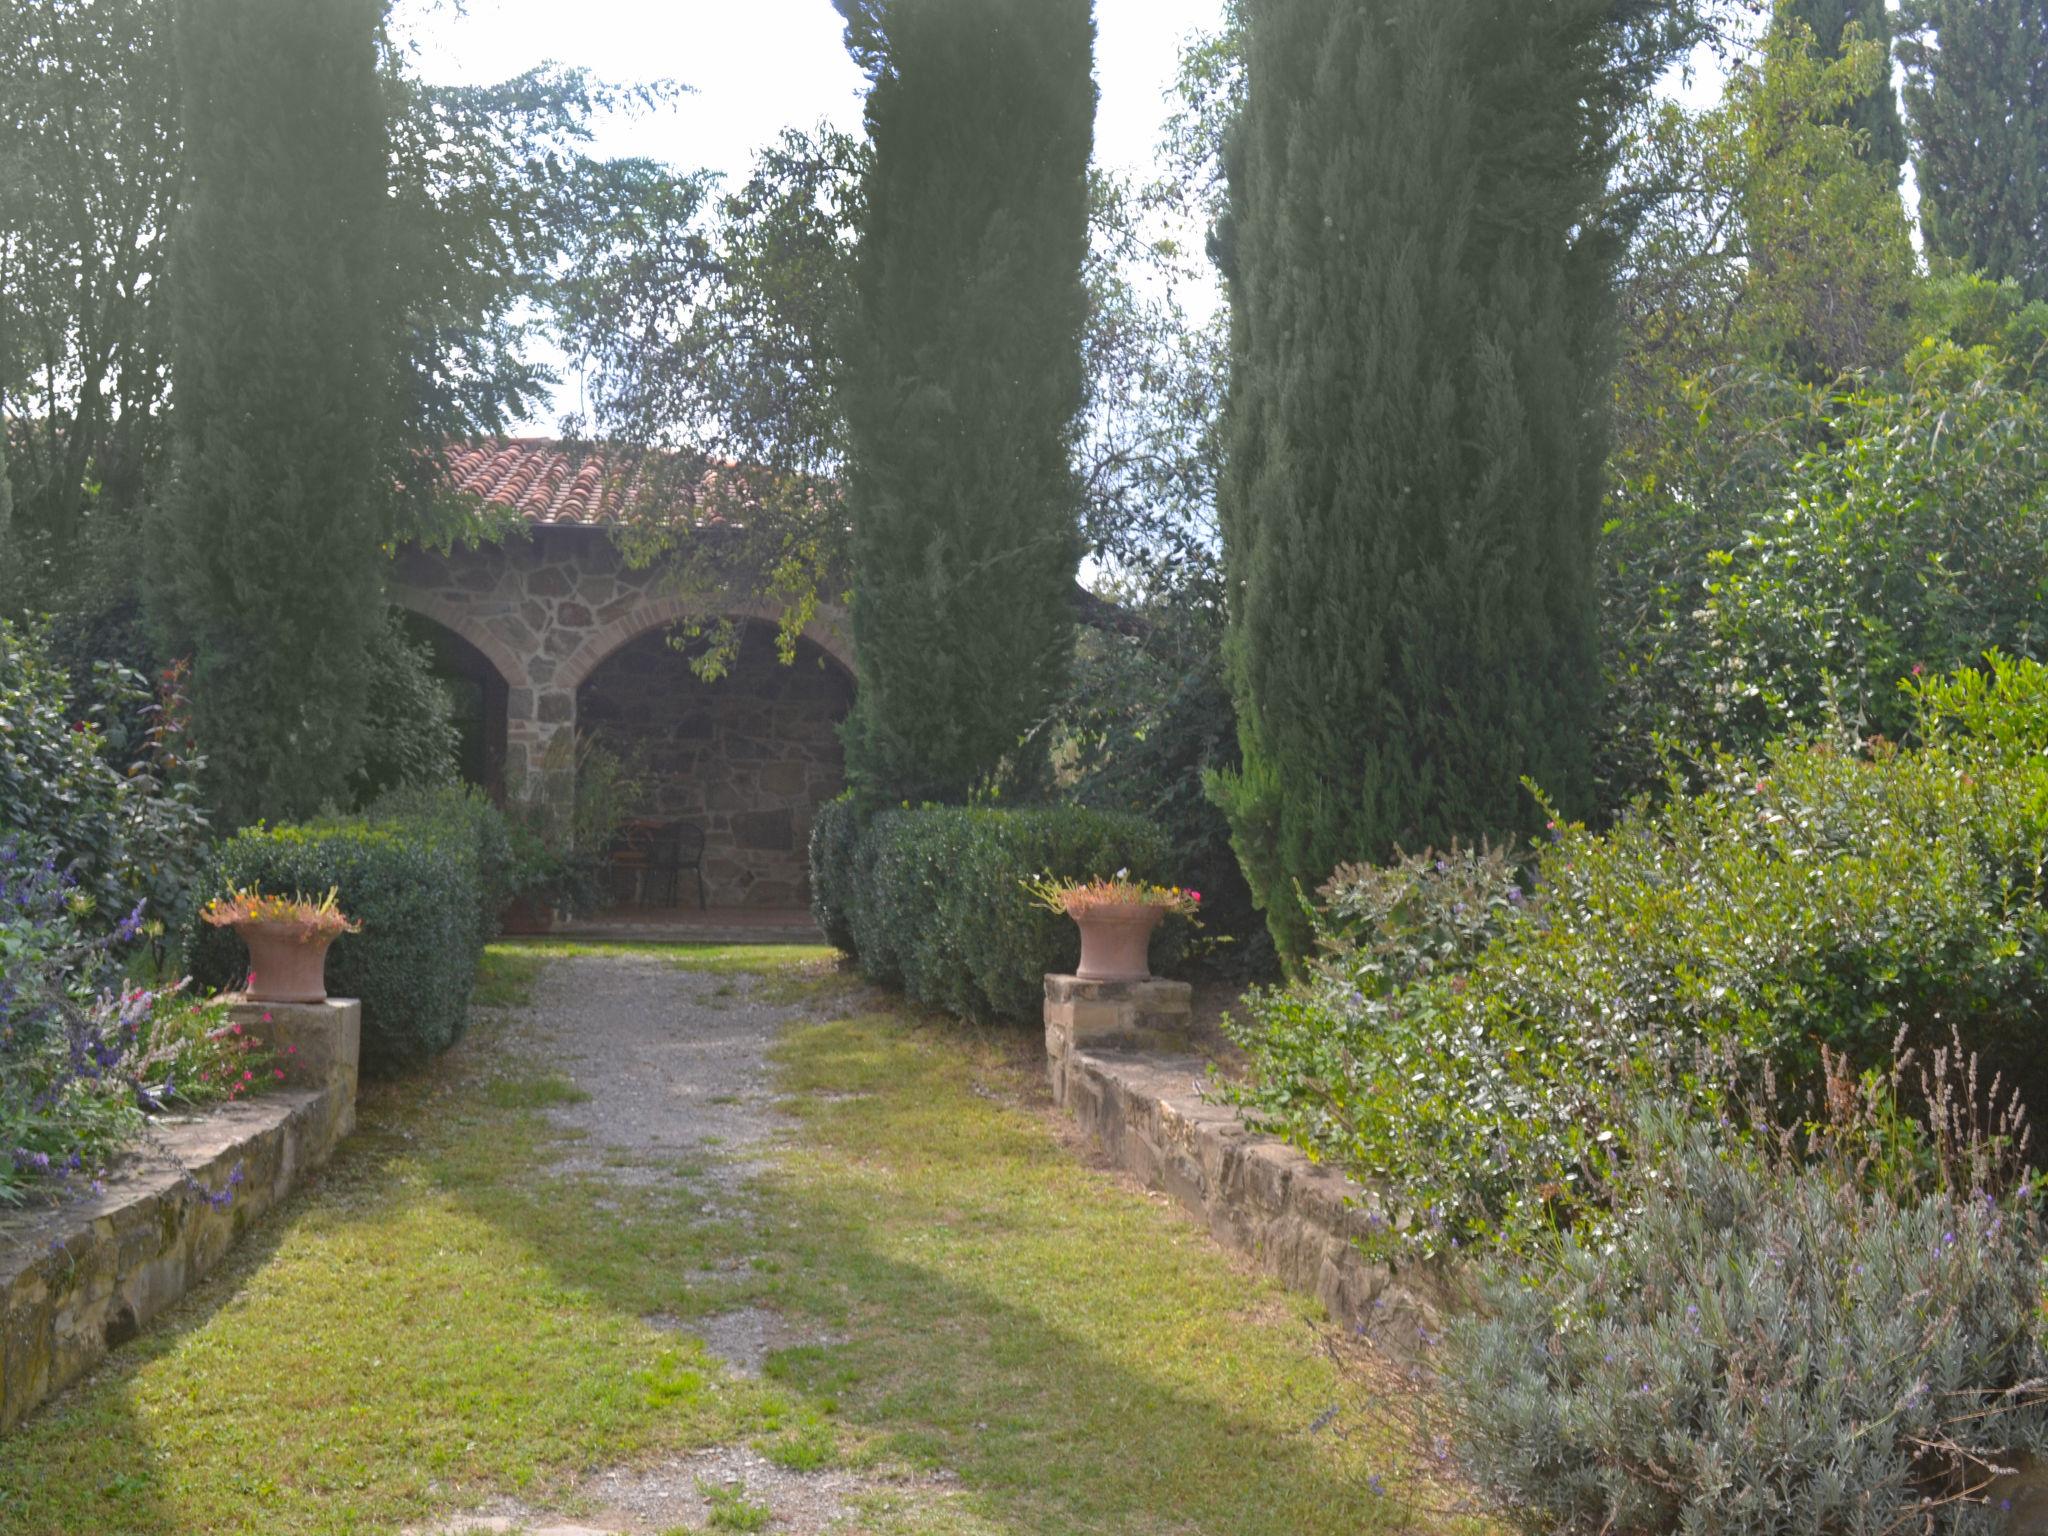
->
1602, 342, 2048, 799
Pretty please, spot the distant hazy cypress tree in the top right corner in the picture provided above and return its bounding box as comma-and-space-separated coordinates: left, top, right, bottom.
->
1903, 0, 2048, 299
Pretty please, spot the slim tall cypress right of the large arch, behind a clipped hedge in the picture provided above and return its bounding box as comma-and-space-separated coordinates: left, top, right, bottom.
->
840, 0, 1096, 801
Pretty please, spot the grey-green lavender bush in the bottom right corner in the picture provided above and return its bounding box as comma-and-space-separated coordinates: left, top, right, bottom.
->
1442, 1116, 2048, 1536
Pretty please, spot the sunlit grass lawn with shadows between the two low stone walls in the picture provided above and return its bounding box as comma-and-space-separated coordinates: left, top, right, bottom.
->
0, 946, 1441, 1536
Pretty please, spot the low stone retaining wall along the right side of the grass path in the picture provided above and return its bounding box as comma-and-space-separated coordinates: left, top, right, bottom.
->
1044, 977, 1452, 1350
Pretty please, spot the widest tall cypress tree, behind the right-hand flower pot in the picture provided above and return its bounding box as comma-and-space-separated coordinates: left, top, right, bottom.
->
1214, 0, 1681, 954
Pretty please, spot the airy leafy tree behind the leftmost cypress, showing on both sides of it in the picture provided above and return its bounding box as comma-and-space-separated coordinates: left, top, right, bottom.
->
0, 0, 647, 638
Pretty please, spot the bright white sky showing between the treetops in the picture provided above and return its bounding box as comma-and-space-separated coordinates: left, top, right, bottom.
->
395, 0, 1223, 432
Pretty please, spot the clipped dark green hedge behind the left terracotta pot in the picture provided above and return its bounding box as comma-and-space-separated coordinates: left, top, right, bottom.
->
188, 795, 504, 1075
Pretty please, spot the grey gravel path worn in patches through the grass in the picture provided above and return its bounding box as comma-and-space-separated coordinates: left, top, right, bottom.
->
428, 958, 946, 1536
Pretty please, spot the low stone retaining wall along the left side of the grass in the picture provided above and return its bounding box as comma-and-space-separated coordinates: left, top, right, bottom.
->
0, 1001, 362, 1434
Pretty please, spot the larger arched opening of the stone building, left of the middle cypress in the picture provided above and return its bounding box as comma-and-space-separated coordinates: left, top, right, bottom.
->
575, 621, 854, 911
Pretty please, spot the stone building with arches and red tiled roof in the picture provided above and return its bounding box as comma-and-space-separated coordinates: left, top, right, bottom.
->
391, 438, 854, 909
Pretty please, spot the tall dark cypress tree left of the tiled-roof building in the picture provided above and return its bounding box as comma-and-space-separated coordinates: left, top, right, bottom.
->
154, 0, 391, 823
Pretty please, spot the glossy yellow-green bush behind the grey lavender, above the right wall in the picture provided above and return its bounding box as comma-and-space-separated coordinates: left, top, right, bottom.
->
1233, 696, 2048, 1251
